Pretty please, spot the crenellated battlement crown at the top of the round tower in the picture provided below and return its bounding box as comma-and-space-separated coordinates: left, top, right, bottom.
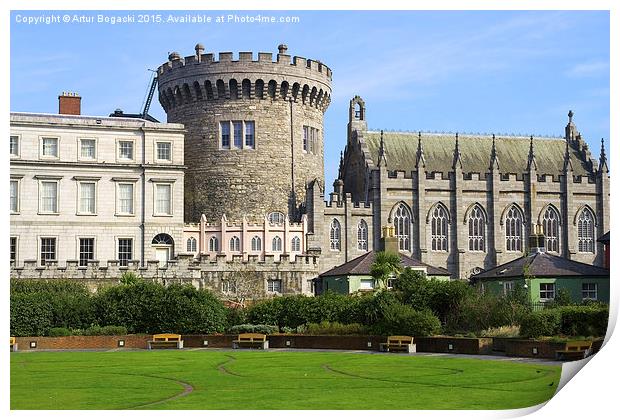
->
157, 44, 332, 112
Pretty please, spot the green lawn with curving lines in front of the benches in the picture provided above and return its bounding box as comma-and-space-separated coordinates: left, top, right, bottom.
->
11, 350, 561, 410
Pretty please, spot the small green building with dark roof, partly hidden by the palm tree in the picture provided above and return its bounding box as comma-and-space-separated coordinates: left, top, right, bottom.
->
316, 251, 450, 294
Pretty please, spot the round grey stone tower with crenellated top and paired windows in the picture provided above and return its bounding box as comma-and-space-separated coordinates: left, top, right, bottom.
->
157, 44, 332, 222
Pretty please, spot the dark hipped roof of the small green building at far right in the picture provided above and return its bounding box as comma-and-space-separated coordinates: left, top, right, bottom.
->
470, 252, 609, 282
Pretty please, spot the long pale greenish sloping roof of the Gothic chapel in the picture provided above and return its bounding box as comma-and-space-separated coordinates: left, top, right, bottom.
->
363, 131, 596, 176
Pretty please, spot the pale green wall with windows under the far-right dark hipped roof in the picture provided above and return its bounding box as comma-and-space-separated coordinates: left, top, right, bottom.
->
484, 277, 609, 303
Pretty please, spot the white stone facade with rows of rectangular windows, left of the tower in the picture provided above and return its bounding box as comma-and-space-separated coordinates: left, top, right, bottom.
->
10, 113, 184, 267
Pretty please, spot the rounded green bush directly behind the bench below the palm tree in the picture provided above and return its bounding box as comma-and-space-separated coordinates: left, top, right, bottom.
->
373, 303, 441, 336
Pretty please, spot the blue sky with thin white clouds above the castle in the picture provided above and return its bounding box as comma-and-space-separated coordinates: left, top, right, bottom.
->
10, 11, 609, 186
